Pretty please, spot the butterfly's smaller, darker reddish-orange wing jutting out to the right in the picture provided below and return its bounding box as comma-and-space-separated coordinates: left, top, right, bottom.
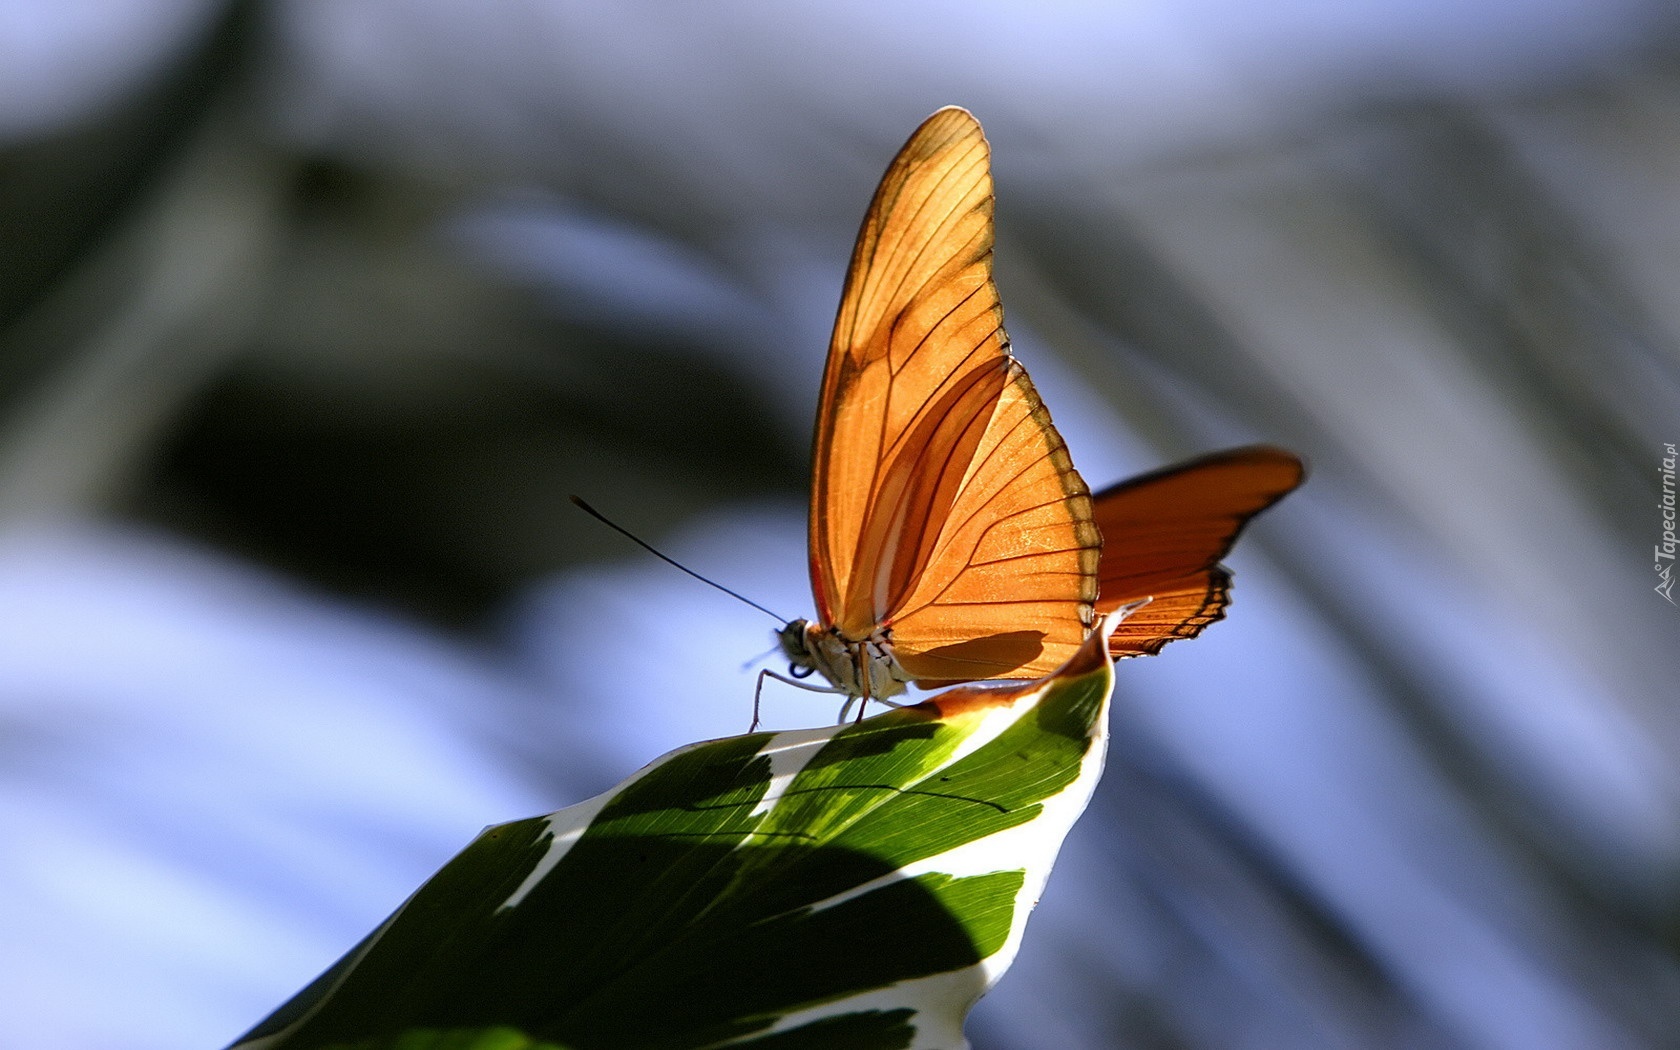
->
1092, 445, 1305, 657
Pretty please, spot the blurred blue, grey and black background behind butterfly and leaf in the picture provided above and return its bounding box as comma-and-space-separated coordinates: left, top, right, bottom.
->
0, 0, 1680, 1050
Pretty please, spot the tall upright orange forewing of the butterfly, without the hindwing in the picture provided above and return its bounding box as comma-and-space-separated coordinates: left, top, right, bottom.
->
811, 111, 1006, 637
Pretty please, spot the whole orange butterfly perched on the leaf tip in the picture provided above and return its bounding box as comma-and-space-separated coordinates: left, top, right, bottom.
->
769, 108, 1300, 721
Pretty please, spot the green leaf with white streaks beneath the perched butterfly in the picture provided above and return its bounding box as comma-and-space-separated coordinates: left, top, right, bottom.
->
226, 621, 1112, 1050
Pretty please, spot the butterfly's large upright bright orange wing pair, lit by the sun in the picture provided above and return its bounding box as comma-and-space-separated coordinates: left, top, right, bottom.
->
810, 109, 1100, 680
